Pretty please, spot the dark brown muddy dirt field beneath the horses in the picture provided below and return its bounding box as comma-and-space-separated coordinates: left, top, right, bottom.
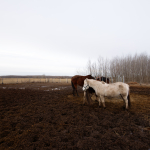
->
0, 83, 150, 150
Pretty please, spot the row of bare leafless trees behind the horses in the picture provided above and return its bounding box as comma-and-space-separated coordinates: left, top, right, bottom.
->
77, 53, 150, 83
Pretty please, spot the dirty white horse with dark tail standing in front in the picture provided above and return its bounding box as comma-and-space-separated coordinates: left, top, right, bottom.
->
83, 78, 130, 109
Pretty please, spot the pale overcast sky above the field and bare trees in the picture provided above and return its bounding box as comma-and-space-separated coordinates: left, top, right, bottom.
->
0, 0, 150, 76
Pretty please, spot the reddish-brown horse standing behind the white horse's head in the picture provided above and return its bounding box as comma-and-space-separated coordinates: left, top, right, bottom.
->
71, 75, 94, 96
